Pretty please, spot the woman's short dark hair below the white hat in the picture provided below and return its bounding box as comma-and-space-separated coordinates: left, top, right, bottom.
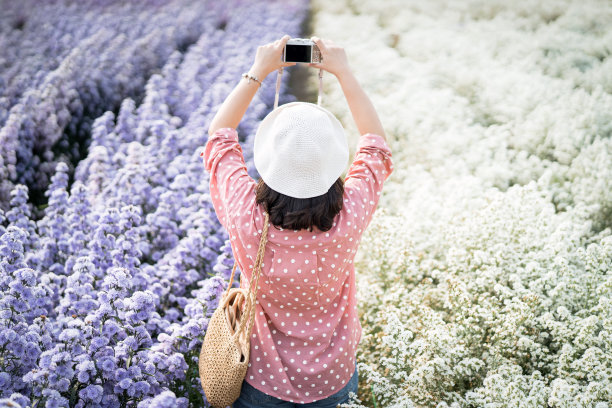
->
255, 177, 344, 232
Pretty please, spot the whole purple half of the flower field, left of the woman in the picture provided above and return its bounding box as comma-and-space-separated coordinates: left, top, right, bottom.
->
0, 0, 307, 408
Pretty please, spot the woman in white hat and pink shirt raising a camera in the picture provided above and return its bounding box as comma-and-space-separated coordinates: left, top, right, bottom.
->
202, 35, 393, 408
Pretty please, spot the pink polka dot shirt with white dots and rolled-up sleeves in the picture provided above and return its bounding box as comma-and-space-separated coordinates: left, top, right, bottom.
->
201, 128, 393, 404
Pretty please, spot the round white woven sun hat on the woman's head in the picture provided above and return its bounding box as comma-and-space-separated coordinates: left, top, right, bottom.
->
253, 102, 349, 198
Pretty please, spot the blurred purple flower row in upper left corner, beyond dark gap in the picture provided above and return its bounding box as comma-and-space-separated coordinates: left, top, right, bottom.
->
0, 0, 230, 219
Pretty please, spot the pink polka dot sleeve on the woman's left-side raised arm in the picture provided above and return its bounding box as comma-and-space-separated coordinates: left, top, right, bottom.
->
200, 128, 256, 235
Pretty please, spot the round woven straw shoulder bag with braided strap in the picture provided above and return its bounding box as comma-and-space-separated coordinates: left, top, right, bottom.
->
199, 212, 268, 408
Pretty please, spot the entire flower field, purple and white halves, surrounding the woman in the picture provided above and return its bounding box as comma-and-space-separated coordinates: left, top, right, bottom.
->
0, 0, 612, 408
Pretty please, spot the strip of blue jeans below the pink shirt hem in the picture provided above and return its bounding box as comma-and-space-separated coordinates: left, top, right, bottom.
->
232, 365, 359, 408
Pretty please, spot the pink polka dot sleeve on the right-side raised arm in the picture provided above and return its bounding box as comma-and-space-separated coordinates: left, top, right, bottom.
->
344, 133, 393, 229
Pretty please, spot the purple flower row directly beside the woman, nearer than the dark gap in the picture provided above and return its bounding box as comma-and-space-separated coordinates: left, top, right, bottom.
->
0, 0, 307, 408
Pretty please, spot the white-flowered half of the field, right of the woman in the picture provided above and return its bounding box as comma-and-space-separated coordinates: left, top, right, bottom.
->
311, 0, 612, 408
